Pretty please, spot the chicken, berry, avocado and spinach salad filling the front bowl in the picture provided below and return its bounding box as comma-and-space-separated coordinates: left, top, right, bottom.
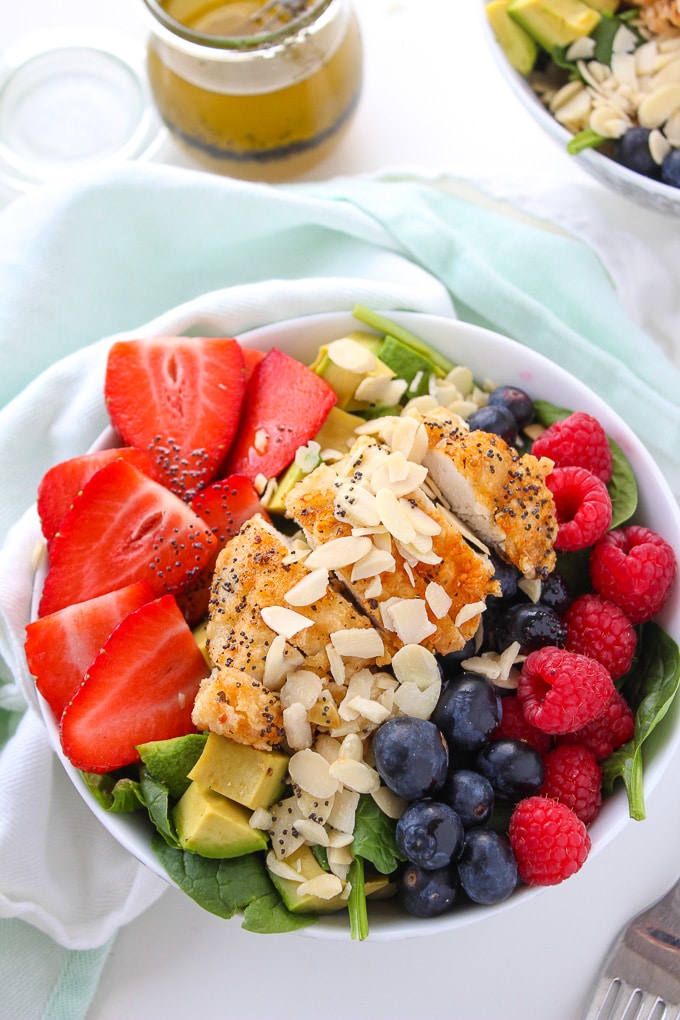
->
25, 306, 680, 938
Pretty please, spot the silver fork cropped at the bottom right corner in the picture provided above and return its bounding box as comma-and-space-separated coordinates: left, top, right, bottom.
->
583, 880, 680, 1020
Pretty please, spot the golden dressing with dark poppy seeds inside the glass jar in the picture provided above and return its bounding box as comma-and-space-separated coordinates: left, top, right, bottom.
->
148, 0, 362, 180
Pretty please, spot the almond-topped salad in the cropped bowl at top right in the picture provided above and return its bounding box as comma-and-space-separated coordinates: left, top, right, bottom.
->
486, 0, 680, 188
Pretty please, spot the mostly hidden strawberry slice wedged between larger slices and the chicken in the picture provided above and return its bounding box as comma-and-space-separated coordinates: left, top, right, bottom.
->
177, 474, 268, 627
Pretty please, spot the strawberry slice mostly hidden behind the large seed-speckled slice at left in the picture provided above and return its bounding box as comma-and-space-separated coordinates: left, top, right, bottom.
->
38, 447, 153, 543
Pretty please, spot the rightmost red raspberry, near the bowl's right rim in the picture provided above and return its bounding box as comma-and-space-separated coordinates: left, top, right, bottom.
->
590, 524, 678, 623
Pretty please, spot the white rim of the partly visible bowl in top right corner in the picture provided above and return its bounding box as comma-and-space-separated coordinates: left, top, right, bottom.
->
481, 0, 680, 216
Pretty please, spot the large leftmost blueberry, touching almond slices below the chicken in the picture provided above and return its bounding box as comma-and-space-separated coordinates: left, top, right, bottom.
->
373, 715, 449, 801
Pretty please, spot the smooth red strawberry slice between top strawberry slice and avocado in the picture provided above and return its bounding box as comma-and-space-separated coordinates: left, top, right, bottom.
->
223, 348, 337, 479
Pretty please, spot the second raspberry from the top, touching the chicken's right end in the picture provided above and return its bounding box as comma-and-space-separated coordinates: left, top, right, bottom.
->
545, 467, 612, 553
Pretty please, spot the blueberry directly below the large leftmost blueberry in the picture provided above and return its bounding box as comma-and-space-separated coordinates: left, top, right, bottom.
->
395, 801, 465, 871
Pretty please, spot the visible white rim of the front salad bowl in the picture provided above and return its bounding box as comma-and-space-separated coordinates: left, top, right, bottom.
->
36, 312, 680, 940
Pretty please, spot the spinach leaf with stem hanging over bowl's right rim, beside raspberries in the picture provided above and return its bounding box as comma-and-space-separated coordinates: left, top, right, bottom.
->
603, 621, 680, 821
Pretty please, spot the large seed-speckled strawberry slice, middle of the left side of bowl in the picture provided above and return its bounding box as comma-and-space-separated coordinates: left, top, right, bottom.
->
40, 460, 215, 616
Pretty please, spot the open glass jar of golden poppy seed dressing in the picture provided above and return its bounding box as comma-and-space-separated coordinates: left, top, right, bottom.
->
144, 0, 362, 180
